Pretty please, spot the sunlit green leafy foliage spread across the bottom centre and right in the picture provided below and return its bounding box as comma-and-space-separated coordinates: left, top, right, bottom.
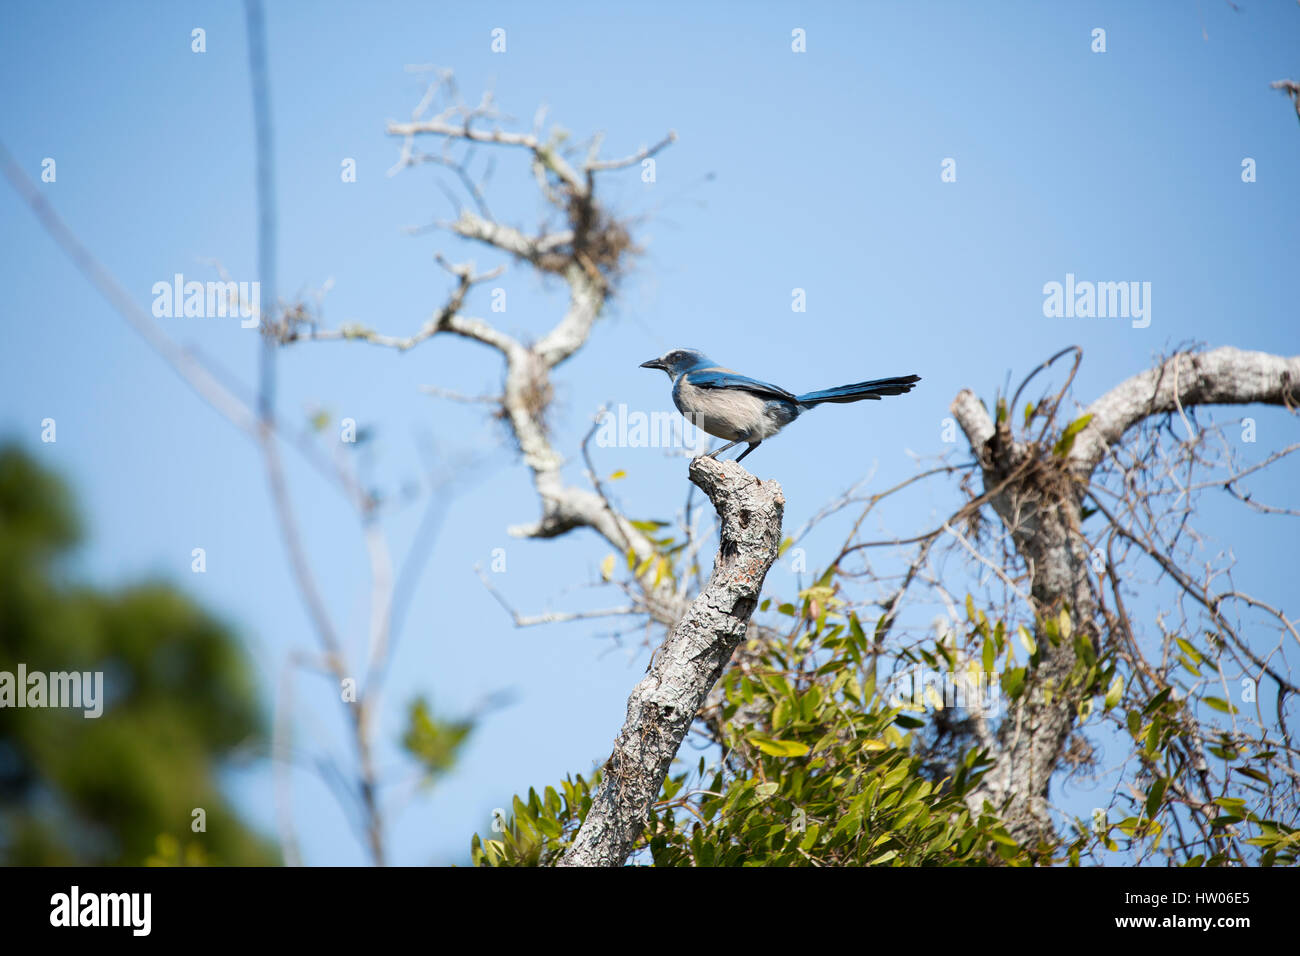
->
472, 546, 1300, 866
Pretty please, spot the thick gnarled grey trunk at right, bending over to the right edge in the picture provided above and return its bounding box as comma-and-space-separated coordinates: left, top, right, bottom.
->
952, 347, 1300, 842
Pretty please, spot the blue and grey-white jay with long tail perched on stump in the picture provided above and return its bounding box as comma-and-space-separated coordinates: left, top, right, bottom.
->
641, 349, 920, 462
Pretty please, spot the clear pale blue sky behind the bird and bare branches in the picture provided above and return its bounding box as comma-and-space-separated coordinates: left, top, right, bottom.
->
0, 0, 1300, 864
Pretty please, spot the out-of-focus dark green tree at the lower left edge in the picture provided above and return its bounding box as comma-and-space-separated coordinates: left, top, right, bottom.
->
0, 445, 277, 865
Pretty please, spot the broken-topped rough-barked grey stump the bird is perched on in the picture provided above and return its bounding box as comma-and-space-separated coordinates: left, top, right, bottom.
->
559, 458, 785, 866
